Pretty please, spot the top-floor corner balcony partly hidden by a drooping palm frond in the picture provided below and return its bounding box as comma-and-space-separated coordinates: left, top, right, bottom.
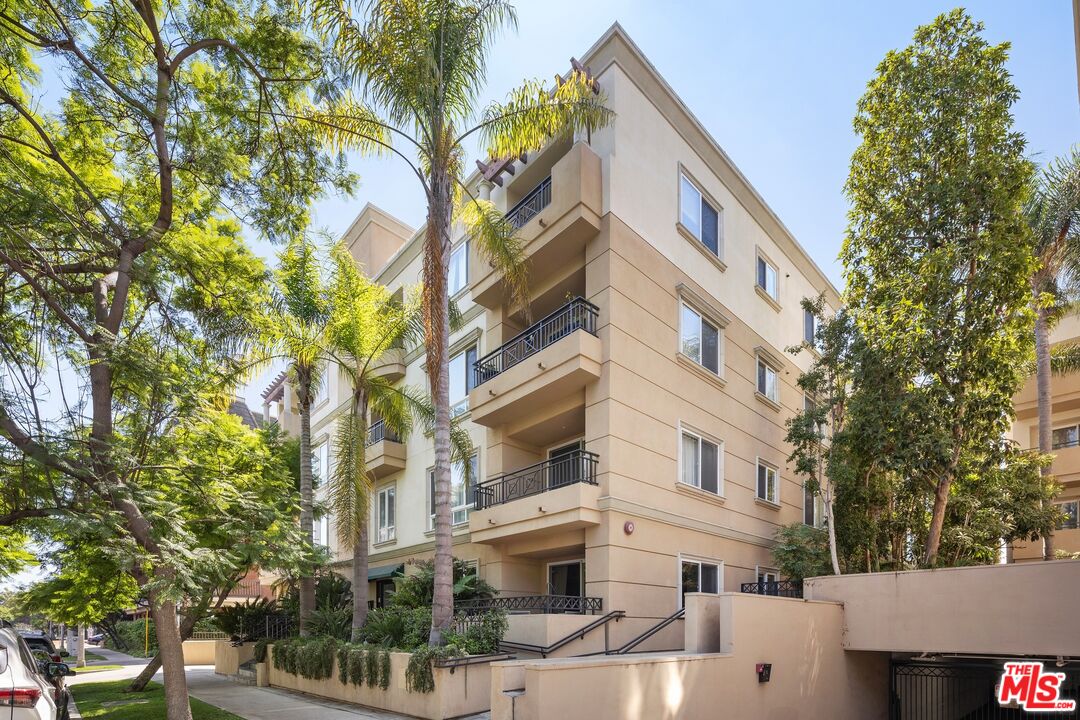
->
469, 142, 603, 309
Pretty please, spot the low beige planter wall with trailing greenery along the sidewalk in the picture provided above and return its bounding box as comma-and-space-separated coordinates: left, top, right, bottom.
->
267, 646, 491, 720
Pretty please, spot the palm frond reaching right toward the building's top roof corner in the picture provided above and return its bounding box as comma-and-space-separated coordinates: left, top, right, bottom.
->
475, 70, 615, 158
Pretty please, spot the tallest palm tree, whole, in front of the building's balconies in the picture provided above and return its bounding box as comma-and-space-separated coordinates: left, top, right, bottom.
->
302, 0, 611, 644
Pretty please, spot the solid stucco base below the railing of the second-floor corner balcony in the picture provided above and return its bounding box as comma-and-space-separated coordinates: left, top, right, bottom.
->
469, 483, 600, 544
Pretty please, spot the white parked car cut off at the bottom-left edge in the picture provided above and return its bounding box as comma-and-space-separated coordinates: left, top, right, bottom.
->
0, 627, 73, 720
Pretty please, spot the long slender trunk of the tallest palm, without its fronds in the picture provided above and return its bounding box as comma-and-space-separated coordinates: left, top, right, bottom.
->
423, 166, 454, 646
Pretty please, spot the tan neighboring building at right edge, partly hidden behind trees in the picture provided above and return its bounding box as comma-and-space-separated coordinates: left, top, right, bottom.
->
1012, 314, 1080, 562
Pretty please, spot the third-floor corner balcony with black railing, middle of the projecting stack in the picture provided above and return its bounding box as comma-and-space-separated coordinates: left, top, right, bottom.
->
469, 298, 602, 445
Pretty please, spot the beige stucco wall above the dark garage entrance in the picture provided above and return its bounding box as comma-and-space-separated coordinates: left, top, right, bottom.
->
804, 560, 1080, 656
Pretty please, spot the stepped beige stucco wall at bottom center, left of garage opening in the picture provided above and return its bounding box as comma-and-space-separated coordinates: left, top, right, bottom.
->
491, 593, 889, 720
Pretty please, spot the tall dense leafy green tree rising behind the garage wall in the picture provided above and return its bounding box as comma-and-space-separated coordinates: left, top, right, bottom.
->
841, 10, 1037, 566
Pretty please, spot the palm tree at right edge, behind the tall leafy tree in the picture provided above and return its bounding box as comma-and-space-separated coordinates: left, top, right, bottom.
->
1025, 148, 1080, 560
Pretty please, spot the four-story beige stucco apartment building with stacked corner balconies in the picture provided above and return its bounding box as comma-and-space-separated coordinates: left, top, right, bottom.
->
265, 25, 839, 648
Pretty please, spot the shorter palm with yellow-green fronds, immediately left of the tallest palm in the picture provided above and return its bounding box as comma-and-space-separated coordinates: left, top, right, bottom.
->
326, 244, 472, 642
